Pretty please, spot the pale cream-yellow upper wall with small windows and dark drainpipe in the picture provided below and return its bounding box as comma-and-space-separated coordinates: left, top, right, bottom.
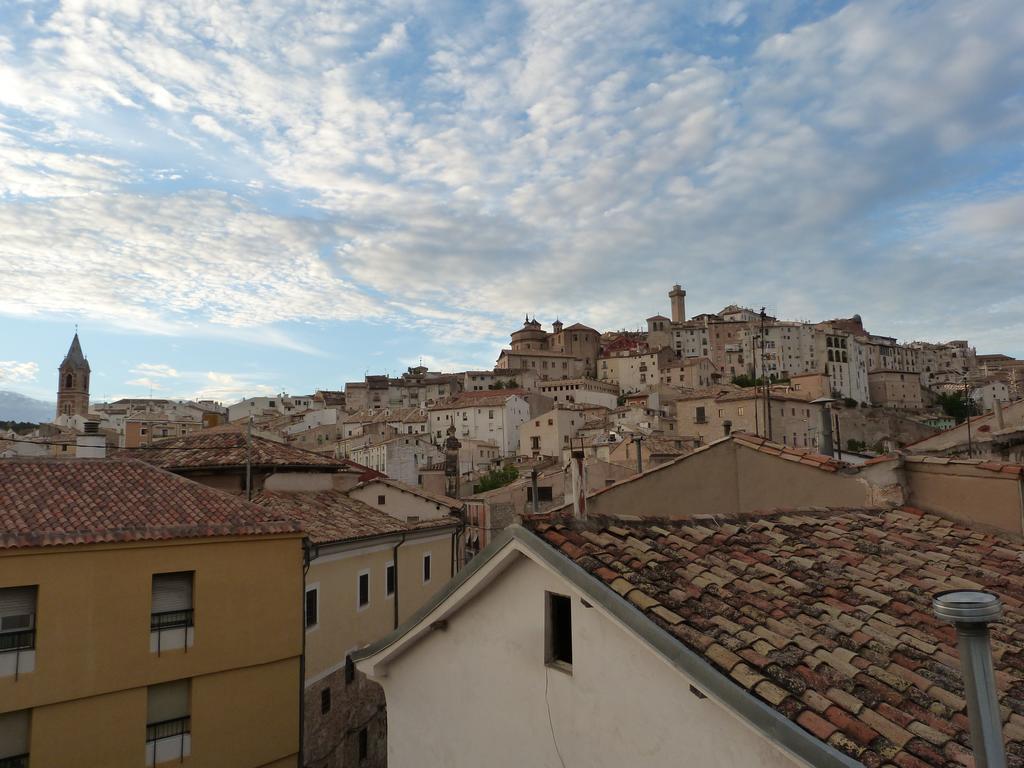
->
306, 530, 452, 681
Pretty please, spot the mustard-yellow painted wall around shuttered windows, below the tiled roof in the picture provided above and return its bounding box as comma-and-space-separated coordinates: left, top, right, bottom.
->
0, 536, 302, 766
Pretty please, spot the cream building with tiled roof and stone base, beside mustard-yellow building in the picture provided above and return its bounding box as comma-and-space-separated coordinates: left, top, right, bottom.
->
254, 489, 460, 768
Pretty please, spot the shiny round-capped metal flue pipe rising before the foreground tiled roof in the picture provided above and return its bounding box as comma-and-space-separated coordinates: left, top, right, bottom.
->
932, 590, 1007, 768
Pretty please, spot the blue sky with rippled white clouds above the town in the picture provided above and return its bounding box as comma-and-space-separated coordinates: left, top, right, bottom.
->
0, 0, 1024, 401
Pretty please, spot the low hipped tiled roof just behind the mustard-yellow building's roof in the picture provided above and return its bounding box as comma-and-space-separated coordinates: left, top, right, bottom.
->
114, 425, 342, 470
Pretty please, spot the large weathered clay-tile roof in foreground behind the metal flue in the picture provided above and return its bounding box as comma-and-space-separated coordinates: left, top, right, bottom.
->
530, 509, 1024, 768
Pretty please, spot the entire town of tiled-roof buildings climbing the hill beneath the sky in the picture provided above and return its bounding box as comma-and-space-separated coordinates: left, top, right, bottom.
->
0, 285, 1024, 768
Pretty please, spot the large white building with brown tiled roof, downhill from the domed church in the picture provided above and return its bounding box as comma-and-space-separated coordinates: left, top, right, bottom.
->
427, 389, 529, 456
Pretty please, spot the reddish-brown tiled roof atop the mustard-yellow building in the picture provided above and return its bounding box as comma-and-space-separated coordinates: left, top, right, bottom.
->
0, 459, 299, 549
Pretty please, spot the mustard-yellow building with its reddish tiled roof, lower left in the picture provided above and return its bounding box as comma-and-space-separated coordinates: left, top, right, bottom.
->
0, 459, 303, 768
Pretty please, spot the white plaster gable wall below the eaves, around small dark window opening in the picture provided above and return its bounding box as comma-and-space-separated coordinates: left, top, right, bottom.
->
379, 556, 803, 768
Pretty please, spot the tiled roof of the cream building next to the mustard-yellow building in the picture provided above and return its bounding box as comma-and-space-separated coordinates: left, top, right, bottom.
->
253, 490, 459, 544
